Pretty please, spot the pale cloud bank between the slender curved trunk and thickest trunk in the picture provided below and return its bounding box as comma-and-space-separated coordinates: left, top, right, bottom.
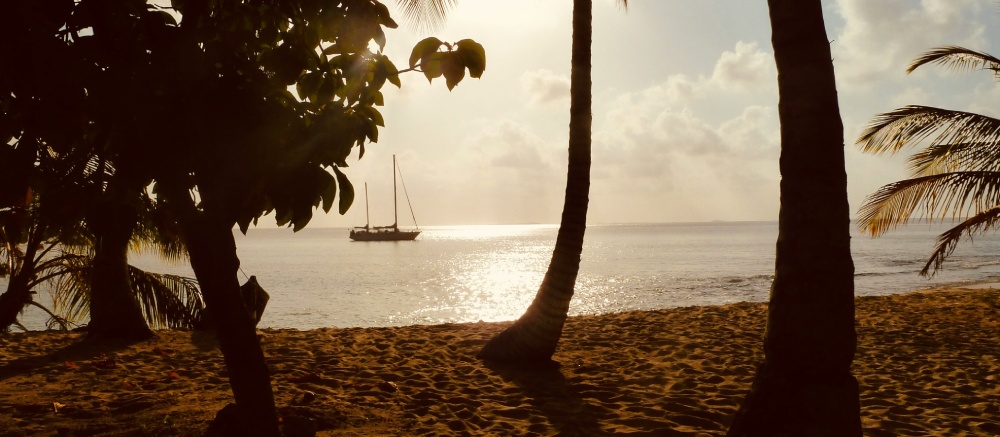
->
593, 42, 779, 221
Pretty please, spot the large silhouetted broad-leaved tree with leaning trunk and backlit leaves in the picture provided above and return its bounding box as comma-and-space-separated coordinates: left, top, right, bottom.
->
0, 0, 485, 435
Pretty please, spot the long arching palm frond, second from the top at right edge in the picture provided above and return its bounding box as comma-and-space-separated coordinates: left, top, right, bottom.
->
856, 105, 1000, 154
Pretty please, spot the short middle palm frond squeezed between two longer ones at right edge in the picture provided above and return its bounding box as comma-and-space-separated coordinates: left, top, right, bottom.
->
907, 142, 1000, 176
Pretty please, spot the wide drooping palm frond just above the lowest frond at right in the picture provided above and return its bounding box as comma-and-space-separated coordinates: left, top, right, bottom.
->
858, 171, 1000, 236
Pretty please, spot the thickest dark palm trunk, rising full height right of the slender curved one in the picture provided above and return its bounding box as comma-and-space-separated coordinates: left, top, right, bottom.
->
728, 0, 861, 436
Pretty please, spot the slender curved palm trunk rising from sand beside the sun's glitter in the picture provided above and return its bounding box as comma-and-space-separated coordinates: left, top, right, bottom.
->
478, 0, 593, 362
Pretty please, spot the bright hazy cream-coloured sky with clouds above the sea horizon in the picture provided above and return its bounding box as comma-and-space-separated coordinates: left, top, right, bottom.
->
302, 0, 1000, 226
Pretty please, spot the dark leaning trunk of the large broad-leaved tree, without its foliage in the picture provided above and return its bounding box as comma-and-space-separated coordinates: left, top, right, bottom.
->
161, 183, 279, 437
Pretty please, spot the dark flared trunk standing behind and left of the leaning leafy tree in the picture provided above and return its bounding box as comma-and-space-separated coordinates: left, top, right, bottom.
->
88, 200, 153, 340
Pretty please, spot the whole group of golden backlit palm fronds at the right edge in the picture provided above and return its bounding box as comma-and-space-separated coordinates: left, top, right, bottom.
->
857, 46, 1000, 275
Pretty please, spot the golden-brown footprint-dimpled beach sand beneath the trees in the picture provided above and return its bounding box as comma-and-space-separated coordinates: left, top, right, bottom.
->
0, 289, 1000, 436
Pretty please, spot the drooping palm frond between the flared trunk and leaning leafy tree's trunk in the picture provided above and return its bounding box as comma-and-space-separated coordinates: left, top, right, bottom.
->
129, 266, 205, 329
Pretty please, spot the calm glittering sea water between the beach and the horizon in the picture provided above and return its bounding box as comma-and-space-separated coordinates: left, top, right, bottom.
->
7, 222, 1000, 329
